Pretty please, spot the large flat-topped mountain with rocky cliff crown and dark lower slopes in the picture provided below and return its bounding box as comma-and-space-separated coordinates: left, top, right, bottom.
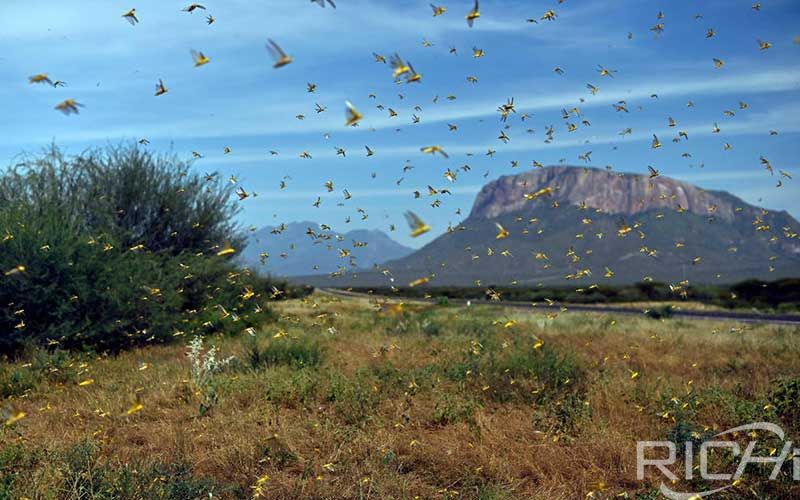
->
290, 166, 800, 287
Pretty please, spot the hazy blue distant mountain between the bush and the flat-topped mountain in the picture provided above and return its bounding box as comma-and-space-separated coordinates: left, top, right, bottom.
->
240, 221, 413, 276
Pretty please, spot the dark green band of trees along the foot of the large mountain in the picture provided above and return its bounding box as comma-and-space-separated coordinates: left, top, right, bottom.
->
352, 278, 800, 312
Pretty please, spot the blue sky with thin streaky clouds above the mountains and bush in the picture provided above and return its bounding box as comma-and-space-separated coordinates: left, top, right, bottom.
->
0, 0, 800, 246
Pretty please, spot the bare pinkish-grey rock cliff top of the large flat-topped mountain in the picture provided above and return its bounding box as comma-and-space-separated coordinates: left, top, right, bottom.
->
470, 166, 755, 221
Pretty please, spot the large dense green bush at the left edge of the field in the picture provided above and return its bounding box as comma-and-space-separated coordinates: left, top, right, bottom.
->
0, 146, 306, 354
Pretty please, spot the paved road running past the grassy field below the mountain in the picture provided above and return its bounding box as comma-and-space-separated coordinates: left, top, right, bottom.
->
317, 288, 800, 326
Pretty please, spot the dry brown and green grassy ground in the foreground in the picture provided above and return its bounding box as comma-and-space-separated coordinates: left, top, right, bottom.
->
0, 295, 800, 499
